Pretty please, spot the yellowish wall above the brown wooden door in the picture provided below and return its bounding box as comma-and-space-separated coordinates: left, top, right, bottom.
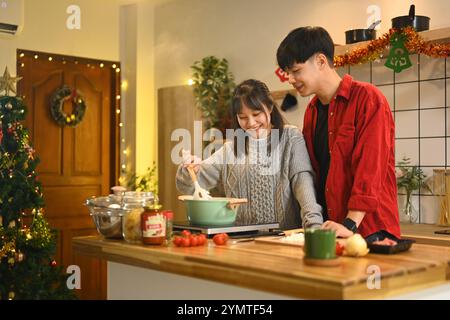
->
0, 0, 119, 74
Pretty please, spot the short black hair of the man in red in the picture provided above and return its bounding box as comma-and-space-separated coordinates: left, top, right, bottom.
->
277, 27, 334, 71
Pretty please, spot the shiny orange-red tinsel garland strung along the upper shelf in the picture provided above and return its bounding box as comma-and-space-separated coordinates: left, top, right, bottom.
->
334, 27, 450, 68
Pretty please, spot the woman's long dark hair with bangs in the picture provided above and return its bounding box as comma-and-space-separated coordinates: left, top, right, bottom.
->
231, 79, 285, 156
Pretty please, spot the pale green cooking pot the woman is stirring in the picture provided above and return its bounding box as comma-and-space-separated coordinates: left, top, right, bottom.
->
178, 196, 247, 226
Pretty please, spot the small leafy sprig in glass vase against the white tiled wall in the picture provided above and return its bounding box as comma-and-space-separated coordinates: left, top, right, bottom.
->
396, 157, 432, 222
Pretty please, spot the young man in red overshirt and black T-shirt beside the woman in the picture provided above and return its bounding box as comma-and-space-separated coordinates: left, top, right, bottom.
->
277, 27, 400, 238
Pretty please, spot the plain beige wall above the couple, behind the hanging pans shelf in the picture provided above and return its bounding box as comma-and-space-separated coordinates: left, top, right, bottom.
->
155, 0, 450, 90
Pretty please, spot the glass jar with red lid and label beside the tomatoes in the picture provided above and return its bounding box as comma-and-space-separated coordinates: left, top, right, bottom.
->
141, 206, 166, 245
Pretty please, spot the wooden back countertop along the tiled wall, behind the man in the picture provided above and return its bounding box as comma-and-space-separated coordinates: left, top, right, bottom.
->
400, 223, 450, 247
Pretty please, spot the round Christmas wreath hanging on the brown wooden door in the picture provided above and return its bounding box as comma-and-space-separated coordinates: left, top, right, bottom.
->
50, 86, 86, 127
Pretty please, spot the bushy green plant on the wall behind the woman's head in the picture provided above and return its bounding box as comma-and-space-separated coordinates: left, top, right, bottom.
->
191, 56, 235, 133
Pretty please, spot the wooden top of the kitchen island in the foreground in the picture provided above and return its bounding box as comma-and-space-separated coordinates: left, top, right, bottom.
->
72, 236, 450, 299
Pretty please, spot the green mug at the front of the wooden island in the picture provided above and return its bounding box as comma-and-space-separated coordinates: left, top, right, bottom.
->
303, 229, 336, 259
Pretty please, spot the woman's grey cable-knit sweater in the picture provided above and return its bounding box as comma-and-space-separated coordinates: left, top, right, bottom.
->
176, 126, 323, 229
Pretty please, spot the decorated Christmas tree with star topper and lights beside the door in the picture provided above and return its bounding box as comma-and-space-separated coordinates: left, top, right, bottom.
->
0, 68, 75, 300
